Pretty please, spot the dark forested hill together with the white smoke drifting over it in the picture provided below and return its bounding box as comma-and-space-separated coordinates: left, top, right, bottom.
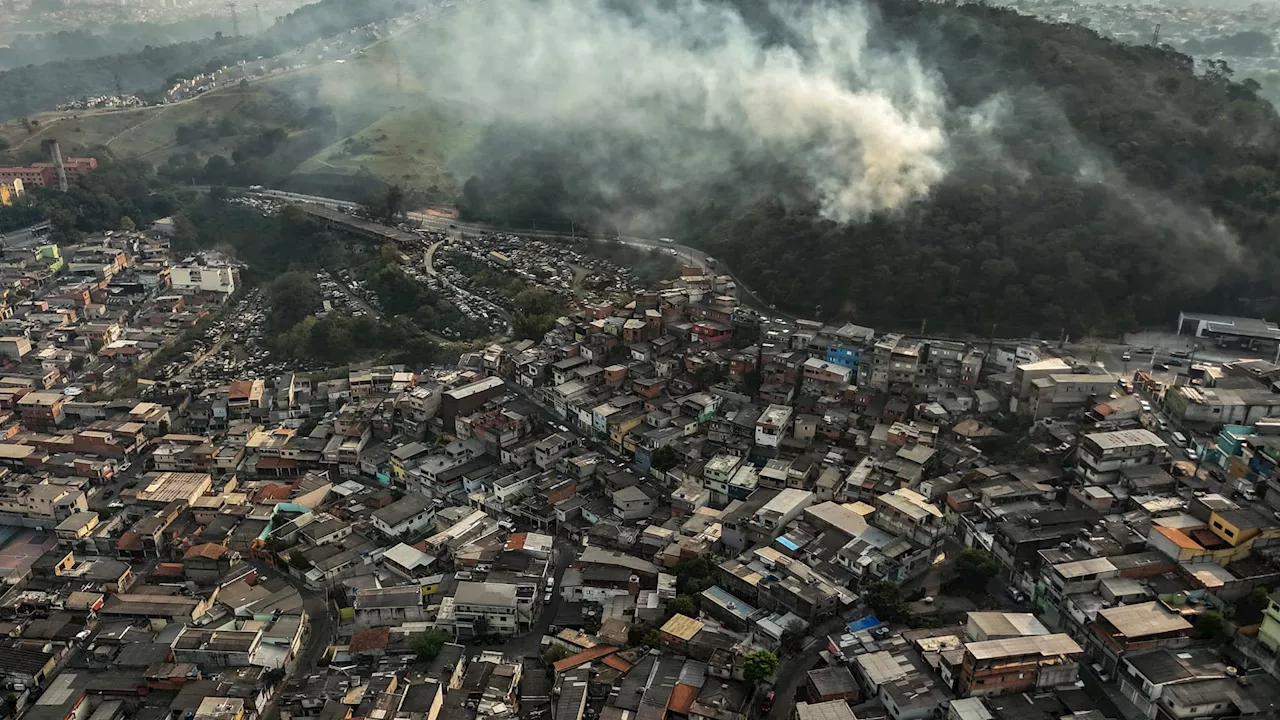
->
430, 0, 1280, 334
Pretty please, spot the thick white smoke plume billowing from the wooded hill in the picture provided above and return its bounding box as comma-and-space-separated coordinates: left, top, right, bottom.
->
420, 0, 947, 222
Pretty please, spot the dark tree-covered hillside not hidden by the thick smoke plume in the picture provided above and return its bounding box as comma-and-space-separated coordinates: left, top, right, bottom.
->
463, 0, 1280, 336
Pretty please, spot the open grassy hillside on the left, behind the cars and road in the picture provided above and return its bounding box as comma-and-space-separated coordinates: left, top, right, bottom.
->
0, 32, 483, 201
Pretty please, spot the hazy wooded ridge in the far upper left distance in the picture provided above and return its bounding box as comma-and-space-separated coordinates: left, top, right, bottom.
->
0, 0, 428, 120
